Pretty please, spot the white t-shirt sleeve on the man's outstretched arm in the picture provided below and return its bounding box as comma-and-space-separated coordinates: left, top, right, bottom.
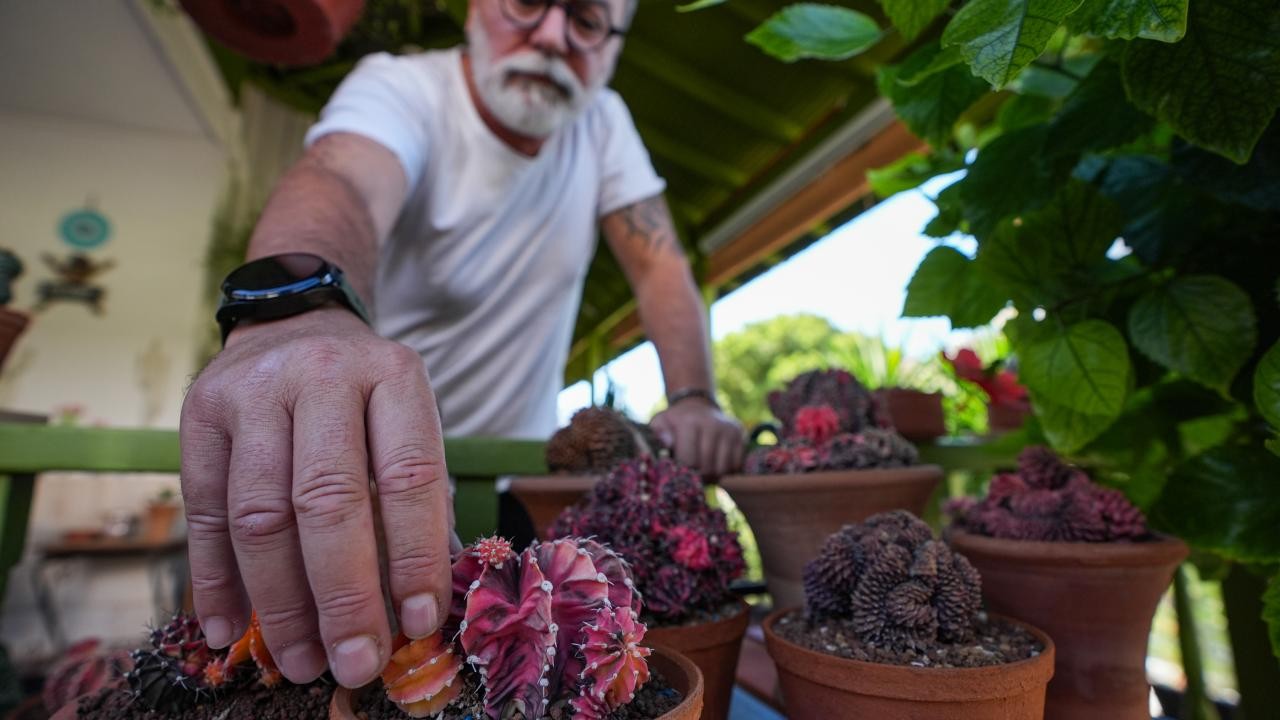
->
306, 53, 431, 191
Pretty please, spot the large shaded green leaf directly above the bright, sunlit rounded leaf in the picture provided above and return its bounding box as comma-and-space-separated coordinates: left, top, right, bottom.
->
977, 181, 1120, 304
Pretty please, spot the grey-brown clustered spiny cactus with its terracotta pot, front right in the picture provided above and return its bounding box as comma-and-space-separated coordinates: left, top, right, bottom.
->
764, 511, 1054, 720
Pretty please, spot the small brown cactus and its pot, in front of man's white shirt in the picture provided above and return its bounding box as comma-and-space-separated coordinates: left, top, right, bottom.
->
511, 407, 664, 538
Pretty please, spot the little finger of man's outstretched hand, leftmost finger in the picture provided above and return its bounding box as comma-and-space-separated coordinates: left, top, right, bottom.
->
179, 407, 250, 648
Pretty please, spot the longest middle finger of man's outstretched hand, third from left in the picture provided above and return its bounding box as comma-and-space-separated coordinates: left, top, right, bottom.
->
291, 379, 390, 688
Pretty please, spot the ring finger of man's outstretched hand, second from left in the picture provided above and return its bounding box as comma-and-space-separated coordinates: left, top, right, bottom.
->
228, 398, 325, 683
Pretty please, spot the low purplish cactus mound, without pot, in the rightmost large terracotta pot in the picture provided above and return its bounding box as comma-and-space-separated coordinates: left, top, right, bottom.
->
946, 446, 1151, 542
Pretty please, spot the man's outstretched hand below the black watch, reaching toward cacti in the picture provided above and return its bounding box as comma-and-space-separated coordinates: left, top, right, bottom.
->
180, 307, 456, 687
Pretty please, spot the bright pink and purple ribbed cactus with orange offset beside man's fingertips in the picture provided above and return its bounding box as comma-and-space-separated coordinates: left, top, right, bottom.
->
384, 538, 648, 719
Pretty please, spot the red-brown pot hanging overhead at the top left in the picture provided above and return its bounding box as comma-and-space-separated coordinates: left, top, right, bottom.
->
182, 0, 365, 65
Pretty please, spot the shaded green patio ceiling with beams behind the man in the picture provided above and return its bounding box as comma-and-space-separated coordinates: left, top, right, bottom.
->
199, 0, 920, 383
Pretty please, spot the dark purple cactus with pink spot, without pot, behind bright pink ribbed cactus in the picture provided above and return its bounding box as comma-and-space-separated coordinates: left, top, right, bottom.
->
550, 460, 745, 621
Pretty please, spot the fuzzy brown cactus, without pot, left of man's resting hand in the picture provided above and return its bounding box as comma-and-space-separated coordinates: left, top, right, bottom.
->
547, 407, 663, 474
